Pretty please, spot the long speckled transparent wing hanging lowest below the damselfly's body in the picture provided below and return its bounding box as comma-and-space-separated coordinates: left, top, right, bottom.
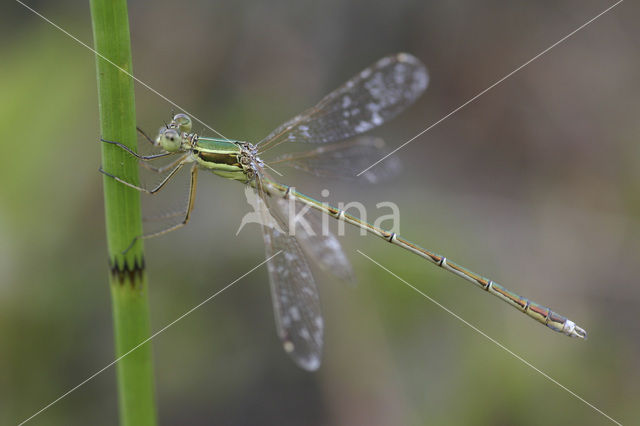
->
256, 176, 324, 371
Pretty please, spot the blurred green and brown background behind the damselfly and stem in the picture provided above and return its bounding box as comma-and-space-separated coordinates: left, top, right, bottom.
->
0, 0, 640, 425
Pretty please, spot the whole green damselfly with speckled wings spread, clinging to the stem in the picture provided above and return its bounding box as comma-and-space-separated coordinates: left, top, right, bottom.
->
103, 53, 586, 370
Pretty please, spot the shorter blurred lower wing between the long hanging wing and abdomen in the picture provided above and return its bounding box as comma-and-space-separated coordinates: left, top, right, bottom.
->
276, 198, 355, 283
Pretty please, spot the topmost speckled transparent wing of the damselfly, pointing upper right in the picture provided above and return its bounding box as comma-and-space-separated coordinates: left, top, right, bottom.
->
258, 53, 429, 152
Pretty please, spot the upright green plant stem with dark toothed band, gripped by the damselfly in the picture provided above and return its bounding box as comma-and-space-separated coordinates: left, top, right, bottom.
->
91, 0, 156, 426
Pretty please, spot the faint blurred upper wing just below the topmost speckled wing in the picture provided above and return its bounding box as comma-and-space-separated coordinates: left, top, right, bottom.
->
267, 136, 402, 183
